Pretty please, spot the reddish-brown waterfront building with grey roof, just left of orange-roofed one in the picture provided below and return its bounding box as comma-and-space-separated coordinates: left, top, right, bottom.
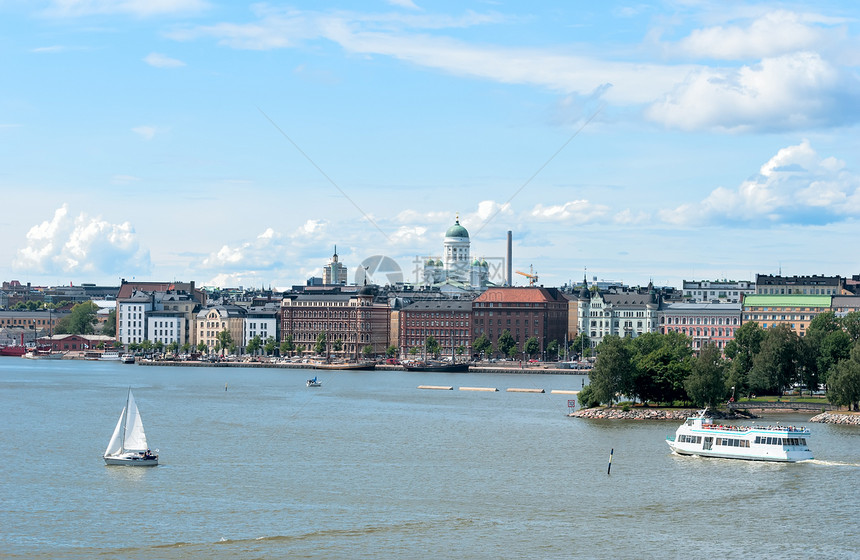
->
398, 299, 472, 358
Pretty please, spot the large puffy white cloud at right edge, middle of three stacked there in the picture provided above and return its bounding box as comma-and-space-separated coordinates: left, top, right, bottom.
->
646, 52, 860, 132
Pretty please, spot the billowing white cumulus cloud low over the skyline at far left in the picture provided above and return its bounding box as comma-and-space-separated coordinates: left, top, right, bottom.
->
13, 204, 151, 276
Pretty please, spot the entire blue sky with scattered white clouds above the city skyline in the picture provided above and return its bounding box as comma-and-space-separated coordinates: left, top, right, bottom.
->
0, 0, 860, 287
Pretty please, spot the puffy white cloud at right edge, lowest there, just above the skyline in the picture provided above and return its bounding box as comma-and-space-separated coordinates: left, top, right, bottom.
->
660, 140, 860, 226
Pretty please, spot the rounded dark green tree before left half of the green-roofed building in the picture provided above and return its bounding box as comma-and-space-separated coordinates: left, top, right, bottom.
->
749, 324, 801, 395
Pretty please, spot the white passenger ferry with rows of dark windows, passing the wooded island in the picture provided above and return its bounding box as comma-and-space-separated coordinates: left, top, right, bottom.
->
666, 410, 813, 463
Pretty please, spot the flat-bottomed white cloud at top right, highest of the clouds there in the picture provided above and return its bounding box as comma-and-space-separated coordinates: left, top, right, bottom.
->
673, 10, 844, 60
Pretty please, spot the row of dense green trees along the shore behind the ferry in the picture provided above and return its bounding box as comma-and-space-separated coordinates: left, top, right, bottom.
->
579, 311, 860, 410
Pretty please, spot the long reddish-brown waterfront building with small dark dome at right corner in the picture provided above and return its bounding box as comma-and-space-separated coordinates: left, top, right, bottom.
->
281, 285, 390, 359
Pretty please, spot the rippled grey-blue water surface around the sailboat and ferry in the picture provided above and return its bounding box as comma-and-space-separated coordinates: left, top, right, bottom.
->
0, 358, 860, 559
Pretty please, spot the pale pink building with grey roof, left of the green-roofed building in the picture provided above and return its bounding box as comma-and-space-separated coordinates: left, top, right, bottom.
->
657, 303, 741, 352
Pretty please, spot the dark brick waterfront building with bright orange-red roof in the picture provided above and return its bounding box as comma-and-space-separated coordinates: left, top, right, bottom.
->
472, 286, 568, 355
